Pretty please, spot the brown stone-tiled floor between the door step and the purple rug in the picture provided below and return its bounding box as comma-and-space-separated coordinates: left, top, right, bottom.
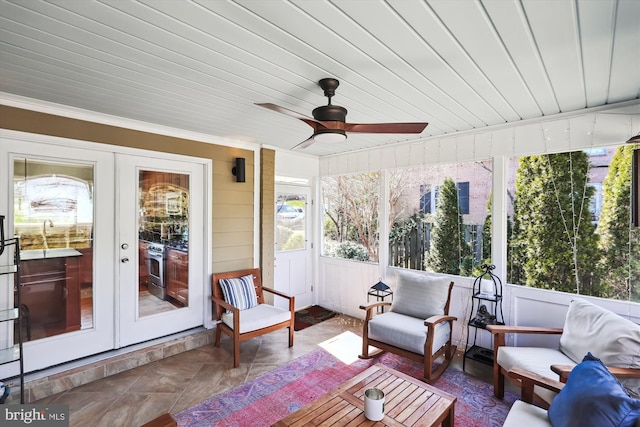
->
35, 316, 491, 427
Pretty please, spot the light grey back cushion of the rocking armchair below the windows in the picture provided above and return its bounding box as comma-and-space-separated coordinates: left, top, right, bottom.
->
391, 270, 451, 320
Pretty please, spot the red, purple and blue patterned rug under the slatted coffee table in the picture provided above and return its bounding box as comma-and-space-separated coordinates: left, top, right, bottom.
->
175, 337, 518, 427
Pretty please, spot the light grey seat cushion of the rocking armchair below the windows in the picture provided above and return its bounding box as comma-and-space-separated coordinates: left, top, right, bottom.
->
369, 311, 451, 355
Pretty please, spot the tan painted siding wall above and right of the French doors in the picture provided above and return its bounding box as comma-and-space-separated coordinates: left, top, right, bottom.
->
0, 105, 258, 274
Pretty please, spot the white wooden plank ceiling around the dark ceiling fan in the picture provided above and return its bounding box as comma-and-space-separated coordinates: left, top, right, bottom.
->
0, 0, 640, 156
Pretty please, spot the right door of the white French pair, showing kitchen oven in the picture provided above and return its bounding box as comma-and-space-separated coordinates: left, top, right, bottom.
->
116, 154, 206, 347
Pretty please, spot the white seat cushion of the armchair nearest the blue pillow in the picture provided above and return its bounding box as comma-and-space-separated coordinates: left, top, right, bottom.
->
497, 346, 575, 403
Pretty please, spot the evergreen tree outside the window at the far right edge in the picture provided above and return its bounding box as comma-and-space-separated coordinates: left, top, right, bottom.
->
598, 145, 640, 301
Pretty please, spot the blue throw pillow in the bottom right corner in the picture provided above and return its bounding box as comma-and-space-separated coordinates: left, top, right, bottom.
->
549, 353, 640, 427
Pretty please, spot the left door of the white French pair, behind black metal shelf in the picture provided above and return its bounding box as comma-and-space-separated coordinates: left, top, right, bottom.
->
0, 138, 115, 377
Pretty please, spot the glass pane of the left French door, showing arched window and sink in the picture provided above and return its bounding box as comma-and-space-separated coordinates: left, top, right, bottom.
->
13, 157, 94, 342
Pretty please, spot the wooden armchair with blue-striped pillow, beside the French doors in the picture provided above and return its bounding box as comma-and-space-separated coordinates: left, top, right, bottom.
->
211, 268, 295, 368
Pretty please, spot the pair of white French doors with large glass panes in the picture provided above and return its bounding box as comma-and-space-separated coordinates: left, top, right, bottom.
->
0, 131, 208, 378
